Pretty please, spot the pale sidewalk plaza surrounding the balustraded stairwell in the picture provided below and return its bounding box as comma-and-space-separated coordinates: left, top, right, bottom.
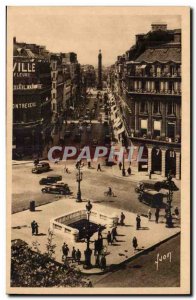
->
11, 197, 180, 274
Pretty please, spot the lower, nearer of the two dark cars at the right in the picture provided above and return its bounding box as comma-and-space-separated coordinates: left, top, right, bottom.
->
138, 189, 168, 207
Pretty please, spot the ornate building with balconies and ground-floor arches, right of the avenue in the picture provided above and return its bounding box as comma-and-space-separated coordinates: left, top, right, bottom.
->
108, 24, 181, 179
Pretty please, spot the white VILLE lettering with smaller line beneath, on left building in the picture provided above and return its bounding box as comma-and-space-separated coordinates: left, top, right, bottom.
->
13, 61, 36, 77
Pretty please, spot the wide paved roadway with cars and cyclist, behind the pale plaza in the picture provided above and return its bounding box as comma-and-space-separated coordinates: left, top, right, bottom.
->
12, 161, 180, 214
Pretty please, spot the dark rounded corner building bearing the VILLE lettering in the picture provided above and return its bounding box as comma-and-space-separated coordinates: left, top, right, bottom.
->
12, 38, 52, 157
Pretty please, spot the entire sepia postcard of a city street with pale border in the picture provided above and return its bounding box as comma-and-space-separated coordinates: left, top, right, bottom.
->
6, 6, 191, 295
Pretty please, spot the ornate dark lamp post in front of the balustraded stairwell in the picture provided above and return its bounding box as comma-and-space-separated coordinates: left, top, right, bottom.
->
84, 201, 93, 269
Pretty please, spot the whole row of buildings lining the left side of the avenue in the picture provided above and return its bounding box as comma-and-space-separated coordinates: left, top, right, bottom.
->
13, 38, 81, 158
